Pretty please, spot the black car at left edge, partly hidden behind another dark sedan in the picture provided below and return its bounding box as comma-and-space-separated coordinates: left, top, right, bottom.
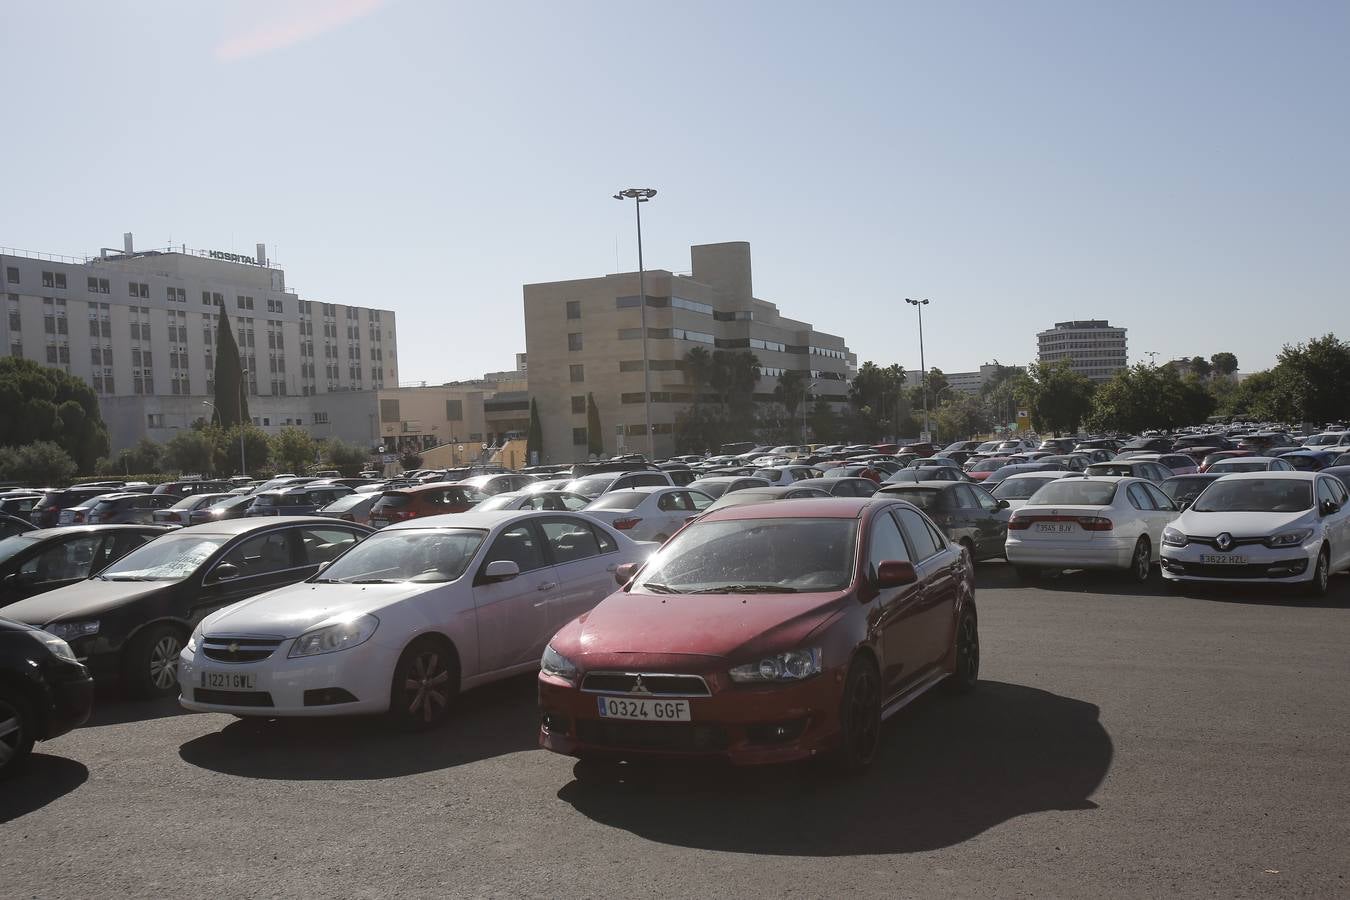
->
0, 525, 173, 609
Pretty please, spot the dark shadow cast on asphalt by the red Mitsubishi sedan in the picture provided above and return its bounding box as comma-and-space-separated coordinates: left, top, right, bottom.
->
558, 681, 1114, 857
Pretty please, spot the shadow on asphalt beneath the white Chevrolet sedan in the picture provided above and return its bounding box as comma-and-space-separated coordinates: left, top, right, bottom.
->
178, 673, 539, 781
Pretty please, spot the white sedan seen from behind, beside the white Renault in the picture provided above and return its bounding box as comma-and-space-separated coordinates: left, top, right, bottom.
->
1007, 476, 1177, 583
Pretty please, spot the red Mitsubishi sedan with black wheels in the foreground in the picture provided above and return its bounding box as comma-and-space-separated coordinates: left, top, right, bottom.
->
539, 494, 980, 770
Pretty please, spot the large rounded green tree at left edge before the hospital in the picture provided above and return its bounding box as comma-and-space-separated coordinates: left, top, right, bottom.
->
0, 356, 108, 472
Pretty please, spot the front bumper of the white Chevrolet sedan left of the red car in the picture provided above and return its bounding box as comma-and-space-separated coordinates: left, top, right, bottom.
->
178, 640, 398, 718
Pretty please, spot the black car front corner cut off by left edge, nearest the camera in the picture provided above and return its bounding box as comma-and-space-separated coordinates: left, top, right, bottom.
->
0, 619, 93, 779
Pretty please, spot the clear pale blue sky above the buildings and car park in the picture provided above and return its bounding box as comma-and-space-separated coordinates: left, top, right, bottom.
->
0, 0, 1350, 382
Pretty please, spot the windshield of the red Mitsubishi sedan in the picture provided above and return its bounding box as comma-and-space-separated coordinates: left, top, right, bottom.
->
635, 518, 857, 594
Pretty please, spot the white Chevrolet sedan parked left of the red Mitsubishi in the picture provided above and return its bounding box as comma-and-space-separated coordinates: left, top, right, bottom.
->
178, 510, 656, 727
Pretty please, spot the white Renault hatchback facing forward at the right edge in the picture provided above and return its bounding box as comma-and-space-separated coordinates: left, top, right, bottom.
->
1162, 471, 1350, 596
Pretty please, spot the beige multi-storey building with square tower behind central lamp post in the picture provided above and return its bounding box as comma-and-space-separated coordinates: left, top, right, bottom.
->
524, 242, 857, 463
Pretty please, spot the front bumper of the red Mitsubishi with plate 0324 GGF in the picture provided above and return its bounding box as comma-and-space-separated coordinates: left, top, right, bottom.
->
539, 669, 845, 765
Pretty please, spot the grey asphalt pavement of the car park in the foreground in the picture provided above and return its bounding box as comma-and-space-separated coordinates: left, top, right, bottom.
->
0, 563, 1350, 897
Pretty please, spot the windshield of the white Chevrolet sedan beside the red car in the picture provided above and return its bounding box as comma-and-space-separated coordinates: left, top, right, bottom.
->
311, 528, 487, 584
